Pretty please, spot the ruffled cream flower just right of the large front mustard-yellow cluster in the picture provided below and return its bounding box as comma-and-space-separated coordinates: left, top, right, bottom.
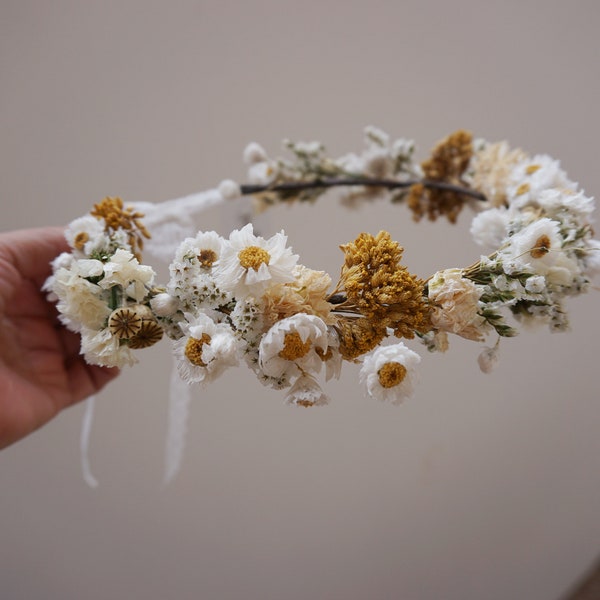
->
428, 269, 486, 341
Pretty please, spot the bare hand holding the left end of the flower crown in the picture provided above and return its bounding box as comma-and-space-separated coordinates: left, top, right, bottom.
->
0, 227, 119, 448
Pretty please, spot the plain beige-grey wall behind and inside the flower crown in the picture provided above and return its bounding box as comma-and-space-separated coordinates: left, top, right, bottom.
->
0, 0, 600, 600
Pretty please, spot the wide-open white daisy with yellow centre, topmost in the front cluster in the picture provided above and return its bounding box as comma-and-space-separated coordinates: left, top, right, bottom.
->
215, 223, 298, 300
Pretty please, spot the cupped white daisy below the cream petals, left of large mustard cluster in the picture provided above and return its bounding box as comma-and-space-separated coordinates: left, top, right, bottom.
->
258, 313, 328, 378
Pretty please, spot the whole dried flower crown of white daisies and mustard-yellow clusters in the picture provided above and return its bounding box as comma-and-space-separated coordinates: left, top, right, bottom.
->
44, 127, 600, 406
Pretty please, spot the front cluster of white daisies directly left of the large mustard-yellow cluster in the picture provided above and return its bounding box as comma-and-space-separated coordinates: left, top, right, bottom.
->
162, 224, 341, 405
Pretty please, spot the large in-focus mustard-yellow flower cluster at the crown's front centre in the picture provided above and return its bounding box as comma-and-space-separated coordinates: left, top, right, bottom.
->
331, 231, 431, 358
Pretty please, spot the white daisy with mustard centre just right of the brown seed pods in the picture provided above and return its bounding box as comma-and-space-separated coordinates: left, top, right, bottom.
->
173, 313, 238, 383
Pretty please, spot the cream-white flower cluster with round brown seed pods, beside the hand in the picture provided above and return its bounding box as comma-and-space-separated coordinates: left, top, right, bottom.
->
44, 204, 157, 367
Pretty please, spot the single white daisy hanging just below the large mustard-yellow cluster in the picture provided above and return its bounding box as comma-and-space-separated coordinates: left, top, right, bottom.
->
359, 342, 421, 404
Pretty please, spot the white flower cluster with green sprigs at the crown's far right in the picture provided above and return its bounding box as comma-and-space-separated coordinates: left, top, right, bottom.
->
465, 144, 600, 346
